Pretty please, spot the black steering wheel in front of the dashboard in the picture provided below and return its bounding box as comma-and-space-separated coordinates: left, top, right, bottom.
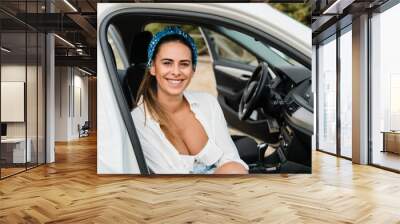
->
239, 62, 270, 120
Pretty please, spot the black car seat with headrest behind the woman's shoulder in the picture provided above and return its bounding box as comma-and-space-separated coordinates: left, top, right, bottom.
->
122, 31, 153, 111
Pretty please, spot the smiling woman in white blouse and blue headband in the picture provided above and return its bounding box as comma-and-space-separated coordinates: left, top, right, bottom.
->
132, 27, 248, 174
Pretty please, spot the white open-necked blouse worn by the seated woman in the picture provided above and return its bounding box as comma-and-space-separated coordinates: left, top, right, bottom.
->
131, 91, 248, 174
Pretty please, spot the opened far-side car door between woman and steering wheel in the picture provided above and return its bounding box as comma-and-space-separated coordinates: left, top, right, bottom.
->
200, 26, 279, 143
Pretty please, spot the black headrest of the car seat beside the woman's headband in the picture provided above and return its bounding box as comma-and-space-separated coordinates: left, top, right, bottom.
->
130, 31, 153, 64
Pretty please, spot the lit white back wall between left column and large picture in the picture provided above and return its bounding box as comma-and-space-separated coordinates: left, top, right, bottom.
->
55, 67, 88, 141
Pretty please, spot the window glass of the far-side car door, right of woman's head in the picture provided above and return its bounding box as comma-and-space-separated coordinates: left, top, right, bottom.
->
207, 30, 258, 66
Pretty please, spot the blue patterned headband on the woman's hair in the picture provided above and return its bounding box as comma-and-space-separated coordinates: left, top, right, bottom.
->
147, 26, 197, 68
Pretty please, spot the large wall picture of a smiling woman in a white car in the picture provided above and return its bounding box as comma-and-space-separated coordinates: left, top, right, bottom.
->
97, 3, 314, 174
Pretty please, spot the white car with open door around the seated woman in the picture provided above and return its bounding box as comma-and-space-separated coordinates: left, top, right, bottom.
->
97, 3, 313, 174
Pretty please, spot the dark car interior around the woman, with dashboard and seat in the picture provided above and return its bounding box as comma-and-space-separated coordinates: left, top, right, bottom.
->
103, 14, 313, 173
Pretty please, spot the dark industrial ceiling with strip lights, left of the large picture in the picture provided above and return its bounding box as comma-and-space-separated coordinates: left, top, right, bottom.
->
0, 0, 117, 73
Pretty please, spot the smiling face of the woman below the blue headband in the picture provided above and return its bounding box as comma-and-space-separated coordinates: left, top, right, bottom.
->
150, 41, 194, 96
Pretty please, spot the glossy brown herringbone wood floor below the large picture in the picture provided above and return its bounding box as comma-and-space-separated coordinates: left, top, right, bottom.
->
0, 134, 400, 224
